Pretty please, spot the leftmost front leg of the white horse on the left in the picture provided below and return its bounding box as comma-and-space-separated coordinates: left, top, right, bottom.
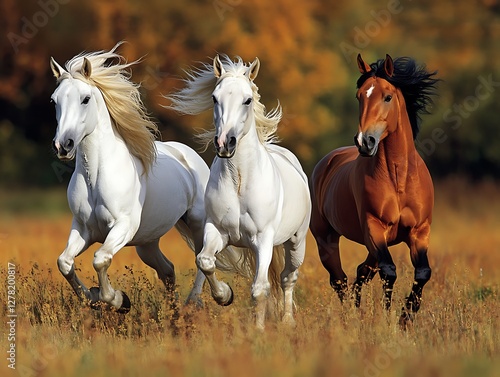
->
57, 220, 98, 302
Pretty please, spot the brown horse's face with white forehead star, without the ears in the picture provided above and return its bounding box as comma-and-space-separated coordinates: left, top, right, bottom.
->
354, 77, 398, 157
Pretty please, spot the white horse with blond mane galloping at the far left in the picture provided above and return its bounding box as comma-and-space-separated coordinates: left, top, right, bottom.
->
50, 44, 209, 312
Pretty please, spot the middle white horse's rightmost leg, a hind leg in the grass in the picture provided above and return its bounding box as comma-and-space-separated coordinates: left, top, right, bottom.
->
281, 234, 306, 325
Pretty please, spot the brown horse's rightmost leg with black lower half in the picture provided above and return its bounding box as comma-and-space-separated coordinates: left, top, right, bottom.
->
400, 224, 431, 325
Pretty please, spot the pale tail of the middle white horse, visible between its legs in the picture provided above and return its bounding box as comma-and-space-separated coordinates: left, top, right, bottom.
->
216, 245, 285, 315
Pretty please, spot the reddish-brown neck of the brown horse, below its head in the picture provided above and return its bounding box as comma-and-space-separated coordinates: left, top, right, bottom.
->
373, 103, 418, 192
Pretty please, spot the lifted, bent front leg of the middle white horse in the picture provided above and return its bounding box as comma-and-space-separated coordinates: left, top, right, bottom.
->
196, 222, 233, 306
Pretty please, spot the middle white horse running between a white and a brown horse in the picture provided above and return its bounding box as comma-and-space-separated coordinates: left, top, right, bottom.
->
168, 56, 311, 328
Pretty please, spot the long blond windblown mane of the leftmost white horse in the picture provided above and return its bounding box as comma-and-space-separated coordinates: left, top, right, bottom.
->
58, 42, 159, 173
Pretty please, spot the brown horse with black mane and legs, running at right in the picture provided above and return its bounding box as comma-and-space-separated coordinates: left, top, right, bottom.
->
311, 55, 438, 323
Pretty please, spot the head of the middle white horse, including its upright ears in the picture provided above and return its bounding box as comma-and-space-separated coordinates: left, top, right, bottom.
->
212, 55, 260, 158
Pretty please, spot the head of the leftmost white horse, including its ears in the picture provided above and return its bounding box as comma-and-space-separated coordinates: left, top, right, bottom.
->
50, 58, 103, 160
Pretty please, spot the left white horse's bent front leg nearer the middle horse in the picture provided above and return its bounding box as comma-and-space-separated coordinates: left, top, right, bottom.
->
91, 220, 137, 313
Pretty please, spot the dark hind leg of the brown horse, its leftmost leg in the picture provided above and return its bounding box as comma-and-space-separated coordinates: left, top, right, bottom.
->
311, 222, 347, 302
